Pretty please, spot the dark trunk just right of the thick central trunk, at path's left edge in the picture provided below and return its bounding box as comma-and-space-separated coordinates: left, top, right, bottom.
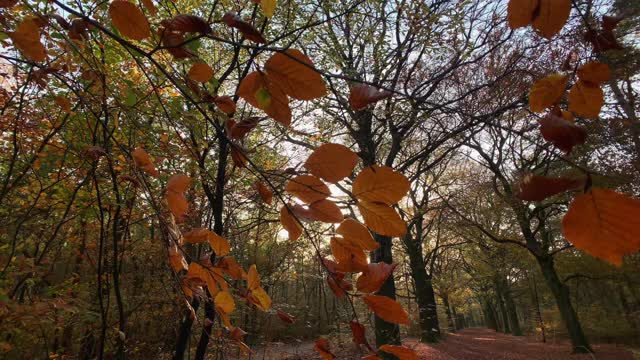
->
405, 233, 440, 343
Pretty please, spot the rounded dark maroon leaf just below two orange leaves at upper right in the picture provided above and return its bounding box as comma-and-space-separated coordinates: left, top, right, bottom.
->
540, 114, 587, 153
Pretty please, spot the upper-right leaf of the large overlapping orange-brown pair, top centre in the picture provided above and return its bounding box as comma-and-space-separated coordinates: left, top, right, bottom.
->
265, 49, 327, 100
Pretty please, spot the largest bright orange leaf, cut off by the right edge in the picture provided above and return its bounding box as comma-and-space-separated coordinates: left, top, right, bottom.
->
562, 188, 640, 266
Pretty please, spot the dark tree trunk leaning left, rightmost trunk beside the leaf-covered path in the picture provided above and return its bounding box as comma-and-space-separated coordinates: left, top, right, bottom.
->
536, 256, 593, 353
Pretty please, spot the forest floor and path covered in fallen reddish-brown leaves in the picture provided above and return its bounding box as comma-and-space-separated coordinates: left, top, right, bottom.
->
251, 328, 638, 360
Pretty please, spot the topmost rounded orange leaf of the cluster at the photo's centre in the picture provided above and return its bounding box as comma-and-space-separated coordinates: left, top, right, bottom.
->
304, 144, 358, 183
